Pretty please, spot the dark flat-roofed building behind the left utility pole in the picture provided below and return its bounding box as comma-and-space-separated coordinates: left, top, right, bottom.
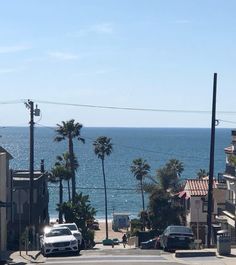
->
8, 164, 49, 248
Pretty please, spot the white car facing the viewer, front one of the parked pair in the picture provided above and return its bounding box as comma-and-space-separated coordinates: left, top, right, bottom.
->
40, 227, 79, 256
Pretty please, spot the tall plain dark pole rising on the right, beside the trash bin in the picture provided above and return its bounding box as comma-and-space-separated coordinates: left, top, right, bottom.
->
207, 73, 217, 248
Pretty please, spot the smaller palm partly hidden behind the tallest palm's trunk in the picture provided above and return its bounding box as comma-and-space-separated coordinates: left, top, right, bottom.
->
57, 152, 79, 201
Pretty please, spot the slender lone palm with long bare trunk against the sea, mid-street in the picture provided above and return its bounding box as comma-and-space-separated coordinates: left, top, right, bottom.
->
93, 136, 112, 239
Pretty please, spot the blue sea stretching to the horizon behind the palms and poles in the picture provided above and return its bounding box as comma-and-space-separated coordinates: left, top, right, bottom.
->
0, 127, 231, 219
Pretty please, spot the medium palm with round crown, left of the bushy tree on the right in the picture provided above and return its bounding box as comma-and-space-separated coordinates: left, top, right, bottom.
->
130, 158, 150, 211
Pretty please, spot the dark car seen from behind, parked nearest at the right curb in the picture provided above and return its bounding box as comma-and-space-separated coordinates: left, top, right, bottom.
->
160, 225, 194, 251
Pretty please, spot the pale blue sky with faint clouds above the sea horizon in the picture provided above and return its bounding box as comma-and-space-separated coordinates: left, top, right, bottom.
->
0, 0, 236, 127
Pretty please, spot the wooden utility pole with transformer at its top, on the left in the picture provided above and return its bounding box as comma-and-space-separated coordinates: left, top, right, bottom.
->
25, 100, 40, 226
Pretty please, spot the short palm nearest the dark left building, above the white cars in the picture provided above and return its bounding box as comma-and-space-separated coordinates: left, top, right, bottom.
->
48, 163, 70, 224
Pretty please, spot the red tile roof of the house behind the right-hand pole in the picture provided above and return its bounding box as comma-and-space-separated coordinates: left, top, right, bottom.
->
184, 179, 216, 196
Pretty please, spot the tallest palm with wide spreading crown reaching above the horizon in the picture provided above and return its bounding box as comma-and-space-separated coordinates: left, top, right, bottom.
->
55, 119, 85, 201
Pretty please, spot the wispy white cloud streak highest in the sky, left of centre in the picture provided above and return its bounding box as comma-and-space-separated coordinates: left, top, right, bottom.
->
69, 23, 113, 37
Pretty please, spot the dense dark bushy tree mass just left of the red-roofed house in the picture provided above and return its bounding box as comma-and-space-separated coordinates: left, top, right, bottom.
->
144, 159, 185, 230
